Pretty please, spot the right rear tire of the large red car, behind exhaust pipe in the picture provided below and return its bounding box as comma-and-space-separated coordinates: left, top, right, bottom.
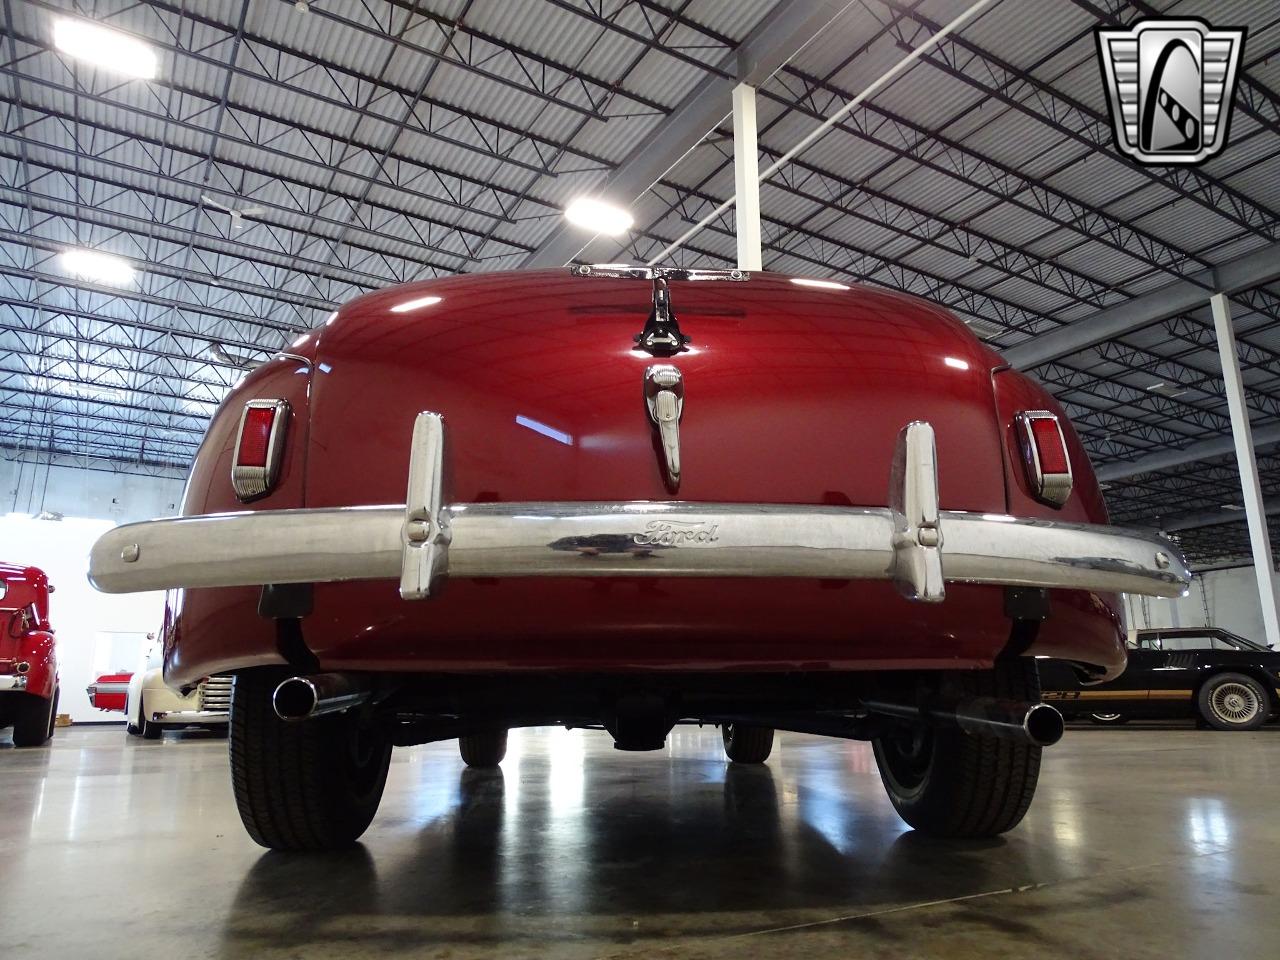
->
872, 659, 1041, 838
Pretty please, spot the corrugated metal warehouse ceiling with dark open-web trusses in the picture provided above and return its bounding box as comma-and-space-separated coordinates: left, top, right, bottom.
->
0, 0, 1280, 566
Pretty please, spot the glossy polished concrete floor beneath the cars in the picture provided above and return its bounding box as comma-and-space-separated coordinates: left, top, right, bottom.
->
0, 727, 1280, 960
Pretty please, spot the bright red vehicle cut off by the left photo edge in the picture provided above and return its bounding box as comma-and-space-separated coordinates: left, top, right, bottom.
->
0, 563, 58, 746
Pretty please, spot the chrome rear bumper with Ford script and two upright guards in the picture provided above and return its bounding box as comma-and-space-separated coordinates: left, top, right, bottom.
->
90, 413, 1190, 609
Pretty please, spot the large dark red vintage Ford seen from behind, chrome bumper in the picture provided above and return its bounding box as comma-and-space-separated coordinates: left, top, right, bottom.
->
91, 265, 1189, 850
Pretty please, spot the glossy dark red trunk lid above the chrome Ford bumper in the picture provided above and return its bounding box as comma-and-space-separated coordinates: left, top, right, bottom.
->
306, 270, 1005, 512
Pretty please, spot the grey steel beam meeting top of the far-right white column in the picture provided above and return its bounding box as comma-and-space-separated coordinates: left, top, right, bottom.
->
1004, 243, 1280, 370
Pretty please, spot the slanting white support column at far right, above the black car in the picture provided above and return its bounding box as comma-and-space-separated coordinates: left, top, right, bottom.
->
1210, 293, 1280, 646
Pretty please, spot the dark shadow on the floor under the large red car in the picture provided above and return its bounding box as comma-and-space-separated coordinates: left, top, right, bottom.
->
215, 760, 1052, 957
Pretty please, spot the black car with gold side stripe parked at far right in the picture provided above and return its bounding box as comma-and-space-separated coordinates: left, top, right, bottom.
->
1039, 627, 1280, 730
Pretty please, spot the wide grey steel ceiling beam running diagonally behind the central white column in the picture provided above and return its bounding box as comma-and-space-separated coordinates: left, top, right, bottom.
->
522, 0, 850, 268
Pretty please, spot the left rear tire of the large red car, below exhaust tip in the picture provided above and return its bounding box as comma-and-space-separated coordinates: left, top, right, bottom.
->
230, 668, 392, 850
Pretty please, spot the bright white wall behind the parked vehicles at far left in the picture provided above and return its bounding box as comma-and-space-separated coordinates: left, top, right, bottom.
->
0, 456, 183, 722
